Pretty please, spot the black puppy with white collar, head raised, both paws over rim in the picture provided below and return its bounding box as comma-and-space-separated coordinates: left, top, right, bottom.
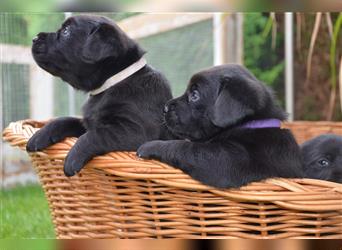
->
27, 15, 172, 176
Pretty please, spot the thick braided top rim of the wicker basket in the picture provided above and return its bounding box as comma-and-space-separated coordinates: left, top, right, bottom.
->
3, 120, 342, 211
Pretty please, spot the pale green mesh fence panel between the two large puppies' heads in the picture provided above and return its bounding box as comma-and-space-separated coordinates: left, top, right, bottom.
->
139, 20, 213, 96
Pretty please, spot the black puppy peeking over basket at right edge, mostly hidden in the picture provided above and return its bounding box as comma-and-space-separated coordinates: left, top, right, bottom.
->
301, 134, 342, 183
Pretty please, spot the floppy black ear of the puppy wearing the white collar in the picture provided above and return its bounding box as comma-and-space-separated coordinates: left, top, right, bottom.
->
82, 23, 121, 63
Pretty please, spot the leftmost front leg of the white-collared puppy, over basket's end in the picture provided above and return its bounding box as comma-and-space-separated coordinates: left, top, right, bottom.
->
26, 117, 86, 152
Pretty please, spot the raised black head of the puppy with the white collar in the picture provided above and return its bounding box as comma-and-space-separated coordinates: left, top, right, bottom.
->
32, 15, 144, 91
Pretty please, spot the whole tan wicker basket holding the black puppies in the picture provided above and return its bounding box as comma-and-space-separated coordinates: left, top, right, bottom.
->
3, 120, 342, 239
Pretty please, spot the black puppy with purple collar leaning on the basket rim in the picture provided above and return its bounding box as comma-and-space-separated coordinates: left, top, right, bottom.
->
137, 64, 303, 188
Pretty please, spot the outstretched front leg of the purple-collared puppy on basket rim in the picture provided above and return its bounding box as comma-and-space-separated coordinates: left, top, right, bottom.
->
137, 140, 243, 188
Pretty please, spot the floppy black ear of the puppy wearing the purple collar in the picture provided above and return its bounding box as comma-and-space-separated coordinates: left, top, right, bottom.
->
209, 78, 254, 128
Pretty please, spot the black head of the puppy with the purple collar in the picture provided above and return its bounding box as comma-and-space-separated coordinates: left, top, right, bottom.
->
164, 64, 286, 140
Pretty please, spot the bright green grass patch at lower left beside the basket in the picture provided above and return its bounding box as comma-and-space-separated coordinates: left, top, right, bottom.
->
0, 185, 55, 239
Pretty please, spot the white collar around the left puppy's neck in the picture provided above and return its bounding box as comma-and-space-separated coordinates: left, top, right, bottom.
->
89, 57, 146, 95
